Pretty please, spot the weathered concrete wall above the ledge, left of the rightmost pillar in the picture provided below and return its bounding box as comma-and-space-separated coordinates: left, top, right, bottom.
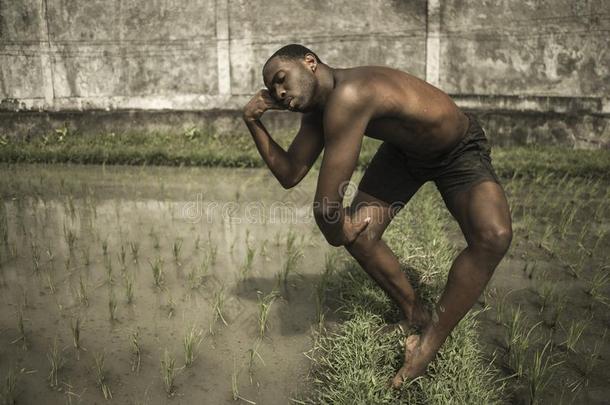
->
0, 0, 426, 111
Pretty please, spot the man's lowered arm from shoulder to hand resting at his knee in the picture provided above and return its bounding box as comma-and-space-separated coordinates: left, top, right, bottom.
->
314, 88, 371, 246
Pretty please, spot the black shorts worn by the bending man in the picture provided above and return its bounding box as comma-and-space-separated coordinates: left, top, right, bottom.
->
358, 113, 500, 208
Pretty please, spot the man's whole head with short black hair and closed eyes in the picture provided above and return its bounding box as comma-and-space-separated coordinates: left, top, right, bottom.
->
263, 44, 322, 112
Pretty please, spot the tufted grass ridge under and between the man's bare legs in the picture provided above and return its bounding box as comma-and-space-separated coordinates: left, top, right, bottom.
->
306, 183, 504, 404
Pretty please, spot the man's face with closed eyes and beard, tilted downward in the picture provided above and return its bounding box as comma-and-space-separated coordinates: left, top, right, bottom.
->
263, 55, 318, 112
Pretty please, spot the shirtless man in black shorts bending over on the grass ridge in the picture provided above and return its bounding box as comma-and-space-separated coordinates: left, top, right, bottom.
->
243, 44, 512, 388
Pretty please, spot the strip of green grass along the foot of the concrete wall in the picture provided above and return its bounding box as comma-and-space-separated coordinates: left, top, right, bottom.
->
0, 128, 610, 178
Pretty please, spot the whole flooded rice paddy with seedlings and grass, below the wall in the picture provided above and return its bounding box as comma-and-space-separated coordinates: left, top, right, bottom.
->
0, 134, 610, 404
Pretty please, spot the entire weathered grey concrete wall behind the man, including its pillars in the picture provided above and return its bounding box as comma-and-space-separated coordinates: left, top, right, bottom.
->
0, 0, 610, 147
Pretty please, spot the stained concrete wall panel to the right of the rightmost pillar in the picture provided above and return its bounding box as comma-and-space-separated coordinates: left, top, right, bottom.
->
440, 0, 610, 97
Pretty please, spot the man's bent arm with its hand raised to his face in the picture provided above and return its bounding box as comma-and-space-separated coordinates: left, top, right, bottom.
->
243, 90, 324, 189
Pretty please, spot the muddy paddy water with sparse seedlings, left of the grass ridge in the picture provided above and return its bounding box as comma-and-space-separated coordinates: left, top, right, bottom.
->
0, 165, 329, 404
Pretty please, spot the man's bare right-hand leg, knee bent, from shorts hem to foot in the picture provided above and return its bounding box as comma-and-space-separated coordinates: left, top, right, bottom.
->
392, 180, 512, 387
